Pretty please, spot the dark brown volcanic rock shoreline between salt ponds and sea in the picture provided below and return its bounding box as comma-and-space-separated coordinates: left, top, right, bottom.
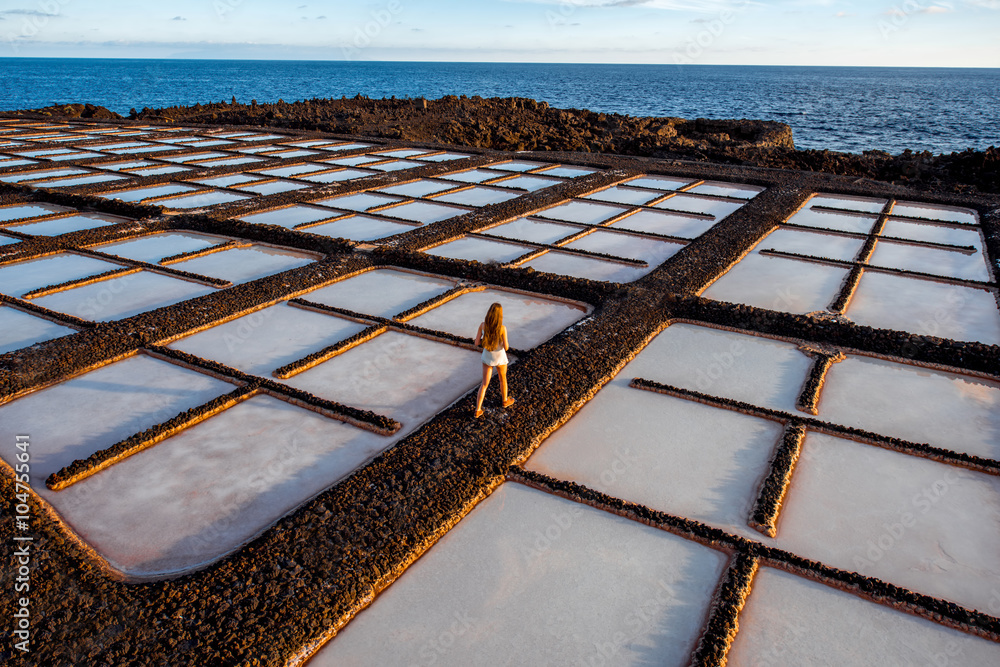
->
20, 95, 1000, 194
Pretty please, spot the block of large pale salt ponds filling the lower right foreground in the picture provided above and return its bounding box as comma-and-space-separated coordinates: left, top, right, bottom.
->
312, 324, 1000, 666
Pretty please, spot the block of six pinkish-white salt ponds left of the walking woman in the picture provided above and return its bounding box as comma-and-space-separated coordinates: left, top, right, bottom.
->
0, 268, 584, 576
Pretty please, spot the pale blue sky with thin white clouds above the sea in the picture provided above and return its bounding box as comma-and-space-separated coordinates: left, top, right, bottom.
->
0, 0, 1000, 67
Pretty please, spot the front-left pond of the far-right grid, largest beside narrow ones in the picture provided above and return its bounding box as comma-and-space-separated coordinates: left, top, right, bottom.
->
702, 252, 852, 314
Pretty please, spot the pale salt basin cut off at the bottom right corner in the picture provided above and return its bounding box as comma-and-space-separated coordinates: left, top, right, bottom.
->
728, 567, 1000, 666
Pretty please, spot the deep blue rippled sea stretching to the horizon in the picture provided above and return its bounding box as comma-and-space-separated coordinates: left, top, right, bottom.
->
0, 58, 1000, 154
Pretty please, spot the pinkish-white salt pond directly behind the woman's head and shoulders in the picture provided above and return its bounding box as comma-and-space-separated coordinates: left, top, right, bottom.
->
409, 288, 589, 350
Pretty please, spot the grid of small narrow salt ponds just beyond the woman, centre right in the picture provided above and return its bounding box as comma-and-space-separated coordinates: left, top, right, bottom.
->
426, 175, 763, 282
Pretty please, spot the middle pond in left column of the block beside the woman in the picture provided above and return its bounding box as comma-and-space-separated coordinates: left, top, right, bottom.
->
170, 303, 365, 375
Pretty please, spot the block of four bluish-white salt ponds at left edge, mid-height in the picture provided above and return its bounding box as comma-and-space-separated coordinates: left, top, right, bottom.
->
0, 232, 317, 326
